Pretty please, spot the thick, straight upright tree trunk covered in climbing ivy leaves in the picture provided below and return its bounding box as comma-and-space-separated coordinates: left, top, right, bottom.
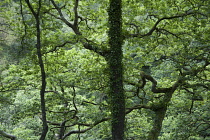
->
107, 0, 125, 140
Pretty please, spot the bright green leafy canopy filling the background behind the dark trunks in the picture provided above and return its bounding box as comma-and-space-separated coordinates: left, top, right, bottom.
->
0, 0, 210, 139
